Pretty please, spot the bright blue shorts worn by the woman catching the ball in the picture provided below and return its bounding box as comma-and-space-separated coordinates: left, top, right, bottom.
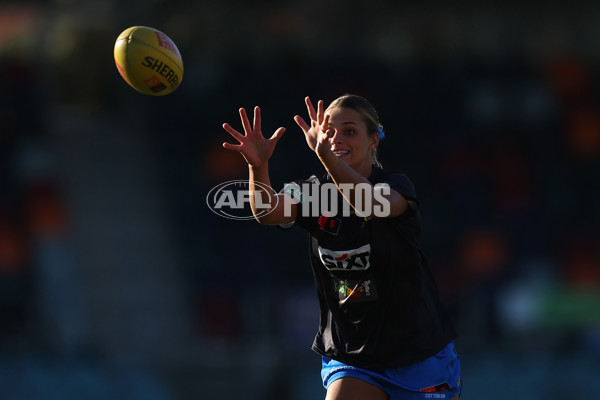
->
321, 342, 462, 400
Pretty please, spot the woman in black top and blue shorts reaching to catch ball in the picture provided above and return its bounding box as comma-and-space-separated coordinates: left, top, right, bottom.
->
223, 95, 461, 400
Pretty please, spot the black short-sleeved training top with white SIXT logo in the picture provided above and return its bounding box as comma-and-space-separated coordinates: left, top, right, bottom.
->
283, 165, 456, 368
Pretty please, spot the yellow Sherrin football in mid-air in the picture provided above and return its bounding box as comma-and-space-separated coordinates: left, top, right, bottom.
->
114, 26, 183, 96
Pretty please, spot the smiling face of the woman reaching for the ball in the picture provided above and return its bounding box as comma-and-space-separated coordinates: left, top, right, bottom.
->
327, 108, 379, 176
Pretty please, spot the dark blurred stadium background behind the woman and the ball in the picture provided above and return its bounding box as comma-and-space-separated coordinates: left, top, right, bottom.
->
0, 0, 600, 400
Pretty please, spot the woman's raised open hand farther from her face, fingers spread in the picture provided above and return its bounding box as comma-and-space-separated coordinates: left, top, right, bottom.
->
223, 107, 285, 167
